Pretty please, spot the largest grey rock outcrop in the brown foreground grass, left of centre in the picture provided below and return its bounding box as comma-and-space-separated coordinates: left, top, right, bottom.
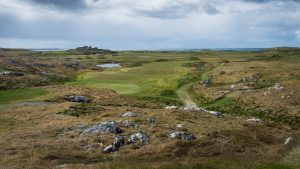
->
81, 121, 123, 135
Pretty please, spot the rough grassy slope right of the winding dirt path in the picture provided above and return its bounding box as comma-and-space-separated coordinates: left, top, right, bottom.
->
189, 50, 299, 127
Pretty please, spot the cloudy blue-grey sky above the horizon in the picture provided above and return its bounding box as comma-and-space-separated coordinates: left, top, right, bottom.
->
0, 0, 300, 49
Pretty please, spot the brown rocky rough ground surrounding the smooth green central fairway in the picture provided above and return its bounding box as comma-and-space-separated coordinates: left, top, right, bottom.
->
0, 49, 300, 169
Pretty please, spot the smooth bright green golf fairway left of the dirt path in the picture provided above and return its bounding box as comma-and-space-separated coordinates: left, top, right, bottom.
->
69, 61, 190, 97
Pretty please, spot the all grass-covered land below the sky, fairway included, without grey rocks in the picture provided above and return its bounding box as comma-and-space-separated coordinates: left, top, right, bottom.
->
0, 49, 300, 169
